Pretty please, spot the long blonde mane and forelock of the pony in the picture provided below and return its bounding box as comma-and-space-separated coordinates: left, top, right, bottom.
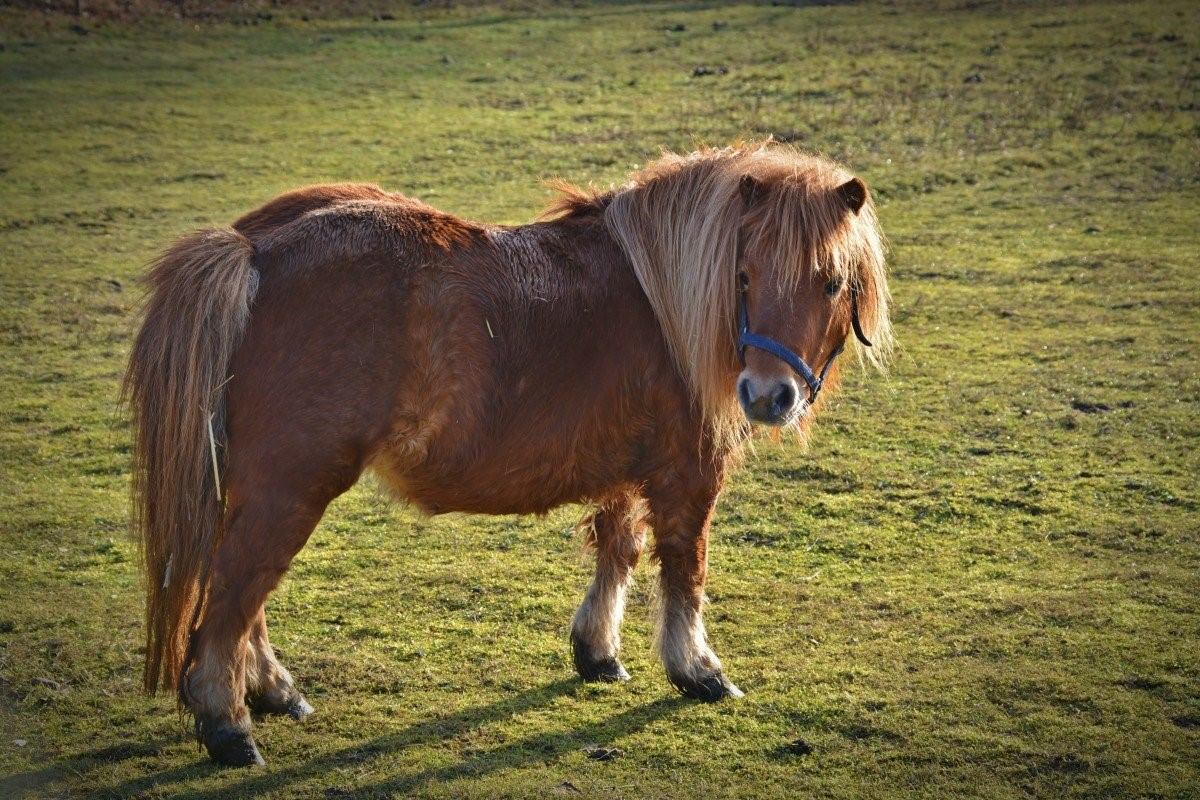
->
600, 140, 893, 441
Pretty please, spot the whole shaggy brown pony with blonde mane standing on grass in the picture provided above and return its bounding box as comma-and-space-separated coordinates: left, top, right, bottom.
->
125, 142, 892, 764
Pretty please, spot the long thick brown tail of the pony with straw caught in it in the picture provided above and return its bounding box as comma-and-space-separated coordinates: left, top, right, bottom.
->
122, 228, 258, 693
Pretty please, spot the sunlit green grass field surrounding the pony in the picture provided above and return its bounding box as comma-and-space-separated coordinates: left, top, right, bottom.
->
0, 2, 1200, 799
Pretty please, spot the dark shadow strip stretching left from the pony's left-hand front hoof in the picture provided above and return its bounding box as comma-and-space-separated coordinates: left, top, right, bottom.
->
100, 679, 609, 800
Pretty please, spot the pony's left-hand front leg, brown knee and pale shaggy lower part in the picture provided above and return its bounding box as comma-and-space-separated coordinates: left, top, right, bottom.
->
571, 497, 646, 682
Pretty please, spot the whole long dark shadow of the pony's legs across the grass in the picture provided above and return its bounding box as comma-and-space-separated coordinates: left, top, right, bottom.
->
63, 679, 688, 800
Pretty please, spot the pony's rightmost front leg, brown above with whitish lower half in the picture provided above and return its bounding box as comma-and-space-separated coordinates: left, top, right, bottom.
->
650, 488, 742, 702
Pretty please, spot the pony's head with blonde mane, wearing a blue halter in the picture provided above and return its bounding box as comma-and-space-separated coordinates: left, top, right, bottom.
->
605, 140, 893, 441
